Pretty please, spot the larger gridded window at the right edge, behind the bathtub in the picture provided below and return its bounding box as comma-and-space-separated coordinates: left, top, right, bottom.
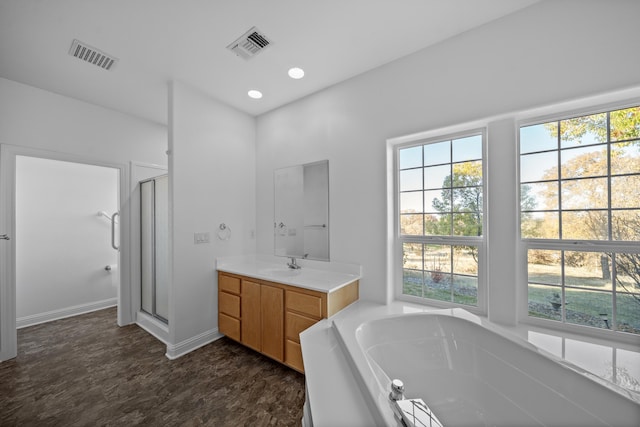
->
519, 106, 640, 334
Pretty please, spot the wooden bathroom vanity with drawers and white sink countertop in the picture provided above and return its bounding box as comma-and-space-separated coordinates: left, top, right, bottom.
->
216, 257, 360, 373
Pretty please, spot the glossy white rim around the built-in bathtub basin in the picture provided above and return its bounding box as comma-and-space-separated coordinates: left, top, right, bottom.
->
331, 302, 640, 425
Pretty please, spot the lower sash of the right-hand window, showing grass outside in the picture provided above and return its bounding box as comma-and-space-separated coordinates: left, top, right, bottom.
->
528, 249, 640, 334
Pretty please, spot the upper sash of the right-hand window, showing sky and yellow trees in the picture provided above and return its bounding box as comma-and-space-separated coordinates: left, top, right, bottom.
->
520, 107, 640, 241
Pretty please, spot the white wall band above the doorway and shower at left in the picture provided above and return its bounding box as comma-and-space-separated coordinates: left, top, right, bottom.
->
0, 78, 167, 165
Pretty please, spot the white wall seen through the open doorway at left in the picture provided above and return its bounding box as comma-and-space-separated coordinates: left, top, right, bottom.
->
16, 156, 119, 326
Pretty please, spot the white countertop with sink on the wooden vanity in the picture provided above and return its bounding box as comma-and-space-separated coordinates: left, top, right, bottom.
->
216, 255, 362, 293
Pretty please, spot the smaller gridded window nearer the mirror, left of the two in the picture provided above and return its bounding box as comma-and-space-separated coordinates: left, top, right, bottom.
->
397, 132, 484, 307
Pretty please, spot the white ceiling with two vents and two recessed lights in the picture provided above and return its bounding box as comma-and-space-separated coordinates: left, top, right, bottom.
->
0, 0, 537, 123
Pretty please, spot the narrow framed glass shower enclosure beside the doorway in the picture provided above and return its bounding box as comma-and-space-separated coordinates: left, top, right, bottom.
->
140, 175, 169, 323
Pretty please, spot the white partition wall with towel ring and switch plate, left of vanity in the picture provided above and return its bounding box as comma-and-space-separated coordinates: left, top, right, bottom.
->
167, 82, 256, 357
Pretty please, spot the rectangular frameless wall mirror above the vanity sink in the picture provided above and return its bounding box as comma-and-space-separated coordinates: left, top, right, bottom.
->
273, 160, 329, 261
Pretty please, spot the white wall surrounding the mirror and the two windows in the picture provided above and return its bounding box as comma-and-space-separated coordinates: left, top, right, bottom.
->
256, 0, 640, 314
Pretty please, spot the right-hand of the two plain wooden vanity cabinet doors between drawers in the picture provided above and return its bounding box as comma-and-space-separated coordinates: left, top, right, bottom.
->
262, 285, 284, 362
